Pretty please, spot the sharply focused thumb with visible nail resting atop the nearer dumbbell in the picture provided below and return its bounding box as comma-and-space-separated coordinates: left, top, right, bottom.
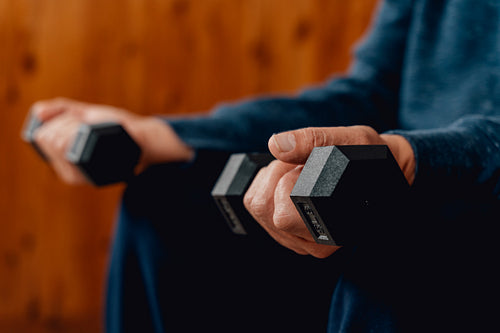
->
268, 126, 384, 164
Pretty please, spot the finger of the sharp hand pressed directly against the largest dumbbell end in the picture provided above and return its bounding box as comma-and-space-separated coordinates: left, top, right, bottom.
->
273, 166, 314, 241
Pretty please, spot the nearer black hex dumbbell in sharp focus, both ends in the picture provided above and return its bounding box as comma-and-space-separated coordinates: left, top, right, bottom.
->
212, 145, 409, 245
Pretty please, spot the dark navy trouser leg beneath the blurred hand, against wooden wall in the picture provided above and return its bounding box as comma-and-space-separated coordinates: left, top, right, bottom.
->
106, 152, 340, 333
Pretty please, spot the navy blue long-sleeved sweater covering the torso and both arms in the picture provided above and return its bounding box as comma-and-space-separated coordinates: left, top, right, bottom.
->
170, 0, 500, 202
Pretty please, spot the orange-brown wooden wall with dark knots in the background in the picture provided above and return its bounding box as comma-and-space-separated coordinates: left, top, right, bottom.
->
0, 0, 376, 332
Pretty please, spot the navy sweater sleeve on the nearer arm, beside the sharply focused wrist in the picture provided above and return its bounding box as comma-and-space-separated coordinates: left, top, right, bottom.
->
388, 116, 499, 195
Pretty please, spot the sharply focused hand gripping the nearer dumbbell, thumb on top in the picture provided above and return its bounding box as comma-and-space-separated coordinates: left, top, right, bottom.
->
244, 126, 415, 258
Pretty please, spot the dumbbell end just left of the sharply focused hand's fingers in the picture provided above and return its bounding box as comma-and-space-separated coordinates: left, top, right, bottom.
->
212, 153, 274, 235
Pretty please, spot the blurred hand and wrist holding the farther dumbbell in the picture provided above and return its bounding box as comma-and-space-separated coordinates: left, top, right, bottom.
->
26, 98, 193, 184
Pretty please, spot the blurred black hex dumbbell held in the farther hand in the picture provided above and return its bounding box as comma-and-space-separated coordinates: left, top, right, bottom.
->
22, 116, 141, 186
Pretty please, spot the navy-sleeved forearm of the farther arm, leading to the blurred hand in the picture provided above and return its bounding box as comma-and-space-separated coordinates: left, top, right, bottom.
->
166, 69, 397, 151
